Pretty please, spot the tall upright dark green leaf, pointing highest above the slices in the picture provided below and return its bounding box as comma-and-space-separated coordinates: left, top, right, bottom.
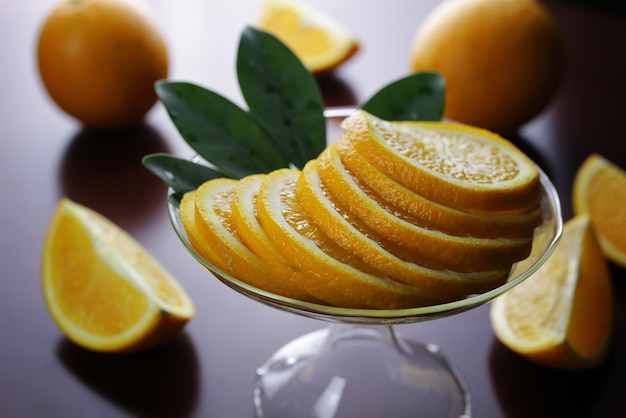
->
237, 27, 326, 168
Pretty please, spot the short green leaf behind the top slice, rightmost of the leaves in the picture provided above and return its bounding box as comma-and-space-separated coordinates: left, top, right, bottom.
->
361, 72, 446, 121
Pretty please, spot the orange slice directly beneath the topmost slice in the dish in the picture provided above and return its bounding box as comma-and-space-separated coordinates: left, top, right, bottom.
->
335, 136, 541, 238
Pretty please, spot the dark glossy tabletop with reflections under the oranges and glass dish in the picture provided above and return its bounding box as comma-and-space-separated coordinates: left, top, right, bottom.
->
0, 0, 626, 418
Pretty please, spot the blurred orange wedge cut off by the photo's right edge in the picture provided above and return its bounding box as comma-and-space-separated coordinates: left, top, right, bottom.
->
572, 154, 626, 268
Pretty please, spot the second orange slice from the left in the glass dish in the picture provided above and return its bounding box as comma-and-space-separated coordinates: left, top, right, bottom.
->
192, 178, 308, 300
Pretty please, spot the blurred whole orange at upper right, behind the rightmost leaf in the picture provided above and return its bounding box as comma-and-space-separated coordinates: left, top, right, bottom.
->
410, 0, 565, 133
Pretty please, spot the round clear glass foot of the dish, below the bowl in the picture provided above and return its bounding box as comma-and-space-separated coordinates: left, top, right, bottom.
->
254, 324, 471, 418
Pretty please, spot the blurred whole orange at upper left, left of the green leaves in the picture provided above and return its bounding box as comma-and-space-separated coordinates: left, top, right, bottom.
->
37, 0, 168, 129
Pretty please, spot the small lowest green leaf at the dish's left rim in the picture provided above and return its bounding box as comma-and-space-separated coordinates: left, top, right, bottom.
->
141, 153, 223, 203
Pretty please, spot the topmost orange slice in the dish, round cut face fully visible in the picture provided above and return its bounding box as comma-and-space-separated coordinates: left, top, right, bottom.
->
342, 110, 540, 213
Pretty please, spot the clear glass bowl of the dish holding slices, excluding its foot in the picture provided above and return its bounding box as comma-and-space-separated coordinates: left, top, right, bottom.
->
168, 165, 563, 325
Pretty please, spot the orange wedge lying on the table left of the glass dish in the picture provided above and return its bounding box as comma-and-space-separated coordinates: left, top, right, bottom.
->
42, 199, 195, 352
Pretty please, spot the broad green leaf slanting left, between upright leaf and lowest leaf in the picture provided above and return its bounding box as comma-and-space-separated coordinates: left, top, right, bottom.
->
156, 82, 289, 178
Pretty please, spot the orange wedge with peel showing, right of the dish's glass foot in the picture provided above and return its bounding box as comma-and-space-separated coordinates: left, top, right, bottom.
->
490, 216, 613, 369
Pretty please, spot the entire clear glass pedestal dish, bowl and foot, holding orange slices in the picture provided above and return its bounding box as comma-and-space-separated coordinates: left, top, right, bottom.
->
169, 165, 562, 418
